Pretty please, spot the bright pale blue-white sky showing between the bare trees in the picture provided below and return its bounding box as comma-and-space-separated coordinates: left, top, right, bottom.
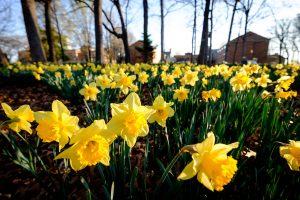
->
0, 0, 300, 61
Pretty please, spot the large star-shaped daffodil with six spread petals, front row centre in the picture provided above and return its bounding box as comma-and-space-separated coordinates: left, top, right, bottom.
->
107, 93, 155, 147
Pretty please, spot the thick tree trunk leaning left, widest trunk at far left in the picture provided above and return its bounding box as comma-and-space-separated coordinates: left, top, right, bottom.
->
21, 0, 46, 62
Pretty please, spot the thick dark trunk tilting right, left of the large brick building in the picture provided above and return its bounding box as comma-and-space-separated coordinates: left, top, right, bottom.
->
197, 0, 210, 65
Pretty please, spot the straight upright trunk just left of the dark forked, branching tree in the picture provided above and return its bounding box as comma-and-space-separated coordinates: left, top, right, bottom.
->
94, 0, 104, 65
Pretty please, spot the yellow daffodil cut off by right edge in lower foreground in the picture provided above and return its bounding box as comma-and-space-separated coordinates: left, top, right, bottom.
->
279, 140, 300, 171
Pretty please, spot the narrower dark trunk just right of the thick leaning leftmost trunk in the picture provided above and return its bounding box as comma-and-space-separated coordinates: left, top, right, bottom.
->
45, 0, 56, 62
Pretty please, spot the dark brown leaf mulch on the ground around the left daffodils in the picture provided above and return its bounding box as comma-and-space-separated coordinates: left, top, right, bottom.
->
0, 77, 154, 200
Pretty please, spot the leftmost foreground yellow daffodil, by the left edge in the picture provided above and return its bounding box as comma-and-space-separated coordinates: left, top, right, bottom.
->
1, 103, 34, 133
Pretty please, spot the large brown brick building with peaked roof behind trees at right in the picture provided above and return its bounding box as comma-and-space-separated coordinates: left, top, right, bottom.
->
216, 31, 270, 63
